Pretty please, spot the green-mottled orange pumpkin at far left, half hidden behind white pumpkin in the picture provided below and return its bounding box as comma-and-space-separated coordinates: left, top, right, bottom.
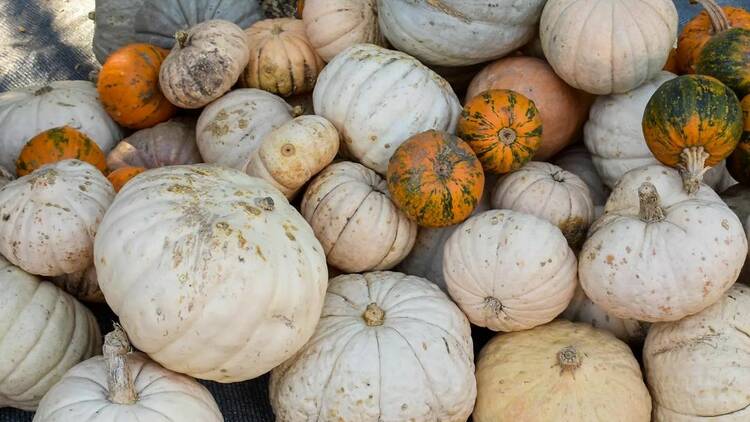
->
16, 126, 107, 176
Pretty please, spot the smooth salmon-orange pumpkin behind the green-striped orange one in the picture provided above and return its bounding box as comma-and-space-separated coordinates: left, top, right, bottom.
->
466, 57, 590, 160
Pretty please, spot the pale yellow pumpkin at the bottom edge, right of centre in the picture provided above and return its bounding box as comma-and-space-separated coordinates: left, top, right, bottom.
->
473, 321, 651, 422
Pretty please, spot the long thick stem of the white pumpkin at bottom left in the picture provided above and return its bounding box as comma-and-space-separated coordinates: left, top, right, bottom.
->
102, 323, 138, 404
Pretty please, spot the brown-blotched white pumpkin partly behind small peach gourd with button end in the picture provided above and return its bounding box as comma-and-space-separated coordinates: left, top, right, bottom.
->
195, 88, 294, 170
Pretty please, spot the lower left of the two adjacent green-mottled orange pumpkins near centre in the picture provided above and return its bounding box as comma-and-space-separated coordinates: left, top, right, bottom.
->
386, 130, 484, 227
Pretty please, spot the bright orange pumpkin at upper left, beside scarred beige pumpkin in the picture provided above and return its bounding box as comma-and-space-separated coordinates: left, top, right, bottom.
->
96, 44, 177, 129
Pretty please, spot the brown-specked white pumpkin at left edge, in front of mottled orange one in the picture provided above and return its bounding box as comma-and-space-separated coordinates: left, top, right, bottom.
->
0, 160, 115, 276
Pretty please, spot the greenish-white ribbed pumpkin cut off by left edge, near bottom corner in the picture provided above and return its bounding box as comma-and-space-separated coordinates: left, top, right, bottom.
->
0, 257, 101, 410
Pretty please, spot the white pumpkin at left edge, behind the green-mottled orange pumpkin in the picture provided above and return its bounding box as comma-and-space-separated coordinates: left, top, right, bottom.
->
0, 81, 122, 173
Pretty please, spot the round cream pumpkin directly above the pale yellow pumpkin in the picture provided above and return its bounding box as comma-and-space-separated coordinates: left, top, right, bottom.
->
443, 210, 577, 331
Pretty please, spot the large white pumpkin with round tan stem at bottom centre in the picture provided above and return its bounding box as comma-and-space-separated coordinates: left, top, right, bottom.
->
270, 272, 476, 422
